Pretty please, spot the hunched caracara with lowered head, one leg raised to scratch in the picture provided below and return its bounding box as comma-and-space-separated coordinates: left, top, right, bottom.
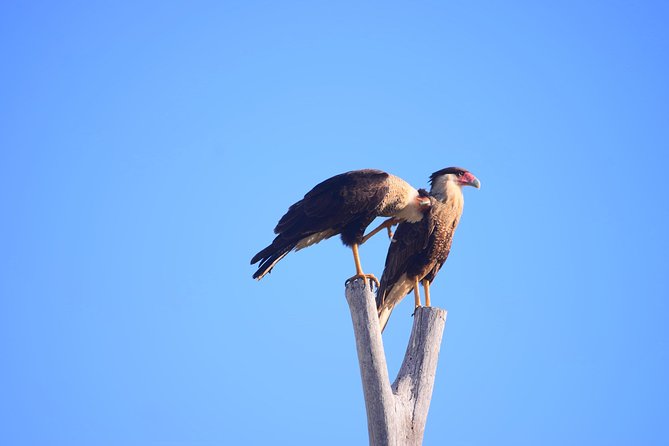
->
251, 169, 430, 287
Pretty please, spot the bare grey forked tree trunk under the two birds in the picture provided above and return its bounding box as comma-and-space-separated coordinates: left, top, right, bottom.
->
346, 279, 446, 446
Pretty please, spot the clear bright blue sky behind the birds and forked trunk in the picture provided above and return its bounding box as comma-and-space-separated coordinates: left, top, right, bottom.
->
0, 1, 669, 446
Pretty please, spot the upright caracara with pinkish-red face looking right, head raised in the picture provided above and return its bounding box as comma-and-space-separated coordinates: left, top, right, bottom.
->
376, 167, 481, 331
